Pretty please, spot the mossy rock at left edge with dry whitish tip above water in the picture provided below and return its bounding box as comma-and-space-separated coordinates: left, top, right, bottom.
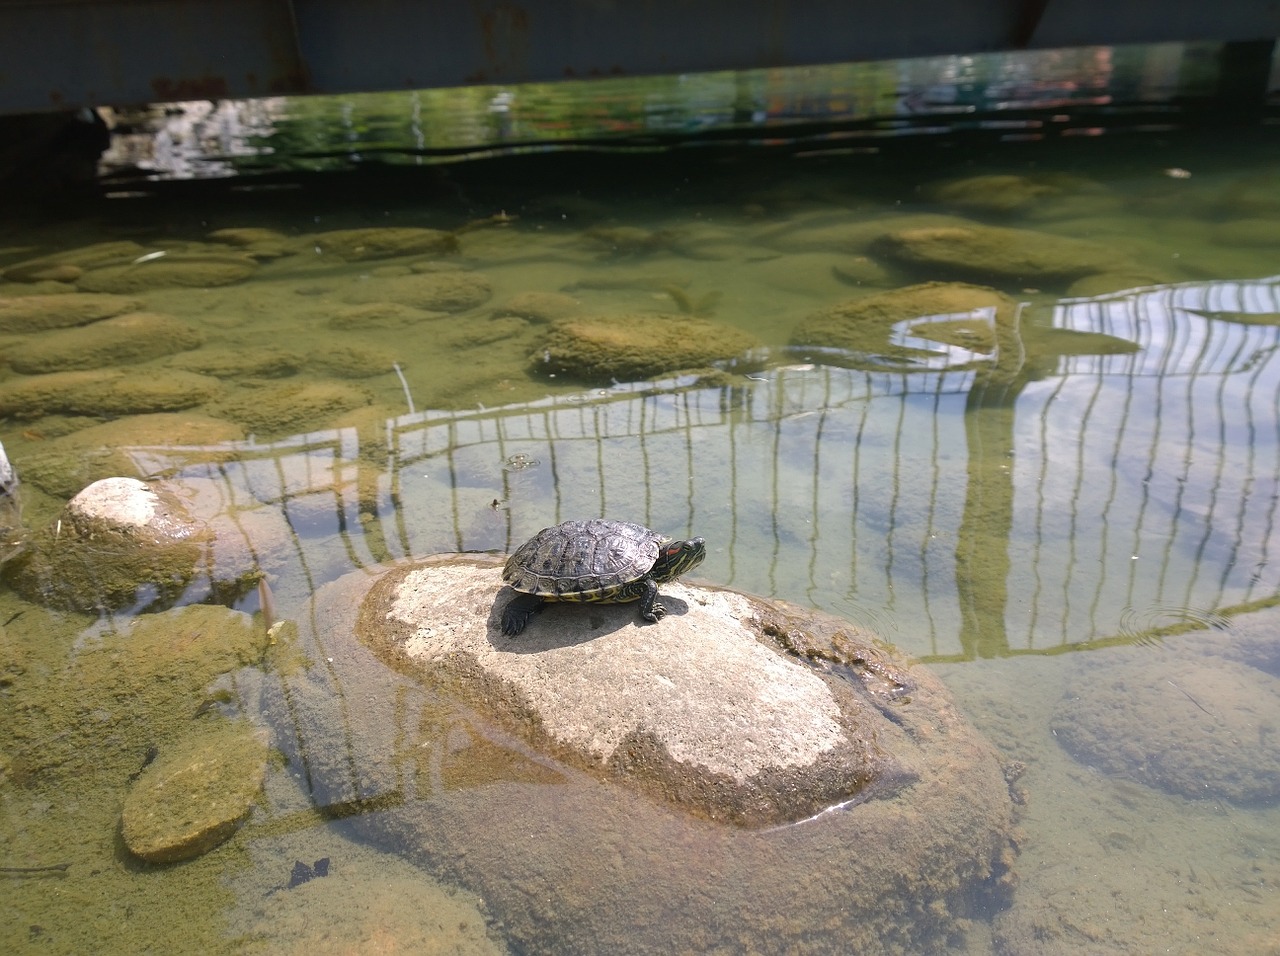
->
4, 477, 212, 610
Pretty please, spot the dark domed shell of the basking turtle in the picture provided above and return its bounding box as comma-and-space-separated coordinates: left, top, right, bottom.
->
502, 518, 671, 601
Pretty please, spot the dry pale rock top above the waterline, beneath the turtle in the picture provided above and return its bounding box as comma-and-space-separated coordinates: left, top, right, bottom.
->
361, 559, 915, 825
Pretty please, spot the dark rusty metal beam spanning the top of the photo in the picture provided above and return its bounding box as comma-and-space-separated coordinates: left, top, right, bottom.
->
0, 0, 1280, 114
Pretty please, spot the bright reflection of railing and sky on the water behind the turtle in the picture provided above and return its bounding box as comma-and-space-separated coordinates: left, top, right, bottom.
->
120, 280, 1280, 657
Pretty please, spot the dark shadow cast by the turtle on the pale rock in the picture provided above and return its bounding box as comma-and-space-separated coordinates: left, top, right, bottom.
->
485, 585, 689, 654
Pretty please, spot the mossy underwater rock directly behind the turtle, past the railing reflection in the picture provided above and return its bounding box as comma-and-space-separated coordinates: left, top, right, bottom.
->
530, 315, 760, 381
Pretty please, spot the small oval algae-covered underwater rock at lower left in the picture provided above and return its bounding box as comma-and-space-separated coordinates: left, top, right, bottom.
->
120, 721, 268, 863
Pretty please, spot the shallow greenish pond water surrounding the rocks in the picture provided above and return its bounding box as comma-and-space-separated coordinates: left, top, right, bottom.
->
0, 50, 1280, 953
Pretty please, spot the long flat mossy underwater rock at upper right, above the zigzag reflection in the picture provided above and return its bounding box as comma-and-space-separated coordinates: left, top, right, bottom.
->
874, 224, 1129, 283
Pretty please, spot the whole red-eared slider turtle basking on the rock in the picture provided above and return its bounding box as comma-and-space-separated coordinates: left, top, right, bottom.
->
502, 518, 707, 637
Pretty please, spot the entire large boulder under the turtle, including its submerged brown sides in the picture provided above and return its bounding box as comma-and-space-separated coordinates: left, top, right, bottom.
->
264, 557, 1014, 952
